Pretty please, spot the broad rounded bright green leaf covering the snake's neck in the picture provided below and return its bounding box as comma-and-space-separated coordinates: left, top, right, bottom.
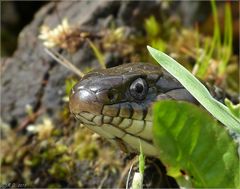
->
153, 101, 240, 188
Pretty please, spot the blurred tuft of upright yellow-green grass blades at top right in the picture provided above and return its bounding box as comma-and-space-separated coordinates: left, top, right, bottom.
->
196, 0, 233, 78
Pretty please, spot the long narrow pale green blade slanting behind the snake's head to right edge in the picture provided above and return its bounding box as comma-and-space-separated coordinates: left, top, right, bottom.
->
147, 46, 240, 134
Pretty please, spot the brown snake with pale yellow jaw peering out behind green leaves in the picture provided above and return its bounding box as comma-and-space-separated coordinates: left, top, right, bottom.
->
69, 63, 232, 157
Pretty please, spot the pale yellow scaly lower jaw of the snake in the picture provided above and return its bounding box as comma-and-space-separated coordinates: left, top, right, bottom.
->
75, 112, 158, 156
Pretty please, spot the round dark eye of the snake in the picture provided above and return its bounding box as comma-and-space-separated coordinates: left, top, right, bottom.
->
130, 78, 148, 100
